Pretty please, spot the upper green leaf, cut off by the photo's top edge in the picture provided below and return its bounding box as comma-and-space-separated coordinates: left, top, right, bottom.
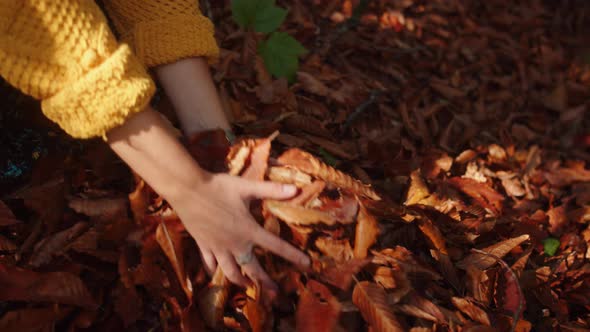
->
231, 0, 287, 33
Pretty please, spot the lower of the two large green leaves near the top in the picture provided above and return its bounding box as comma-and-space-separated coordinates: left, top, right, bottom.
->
258, 32, 307, 82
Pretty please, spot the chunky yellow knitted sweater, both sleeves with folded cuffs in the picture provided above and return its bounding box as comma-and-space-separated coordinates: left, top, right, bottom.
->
0, 0, 219, 138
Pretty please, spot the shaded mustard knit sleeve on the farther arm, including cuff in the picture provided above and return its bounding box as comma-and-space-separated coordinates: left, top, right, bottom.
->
103, 0, 219, 67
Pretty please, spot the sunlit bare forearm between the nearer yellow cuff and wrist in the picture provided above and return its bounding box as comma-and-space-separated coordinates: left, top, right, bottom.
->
107, 107, 207, 200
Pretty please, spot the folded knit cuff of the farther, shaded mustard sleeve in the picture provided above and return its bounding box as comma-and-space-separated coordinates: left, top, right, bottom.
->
131, 15, 219, 67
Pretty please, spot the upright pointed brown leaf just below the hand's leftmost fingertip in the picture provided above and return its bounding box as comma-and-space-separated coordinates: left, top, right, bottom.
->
197, 266, 230, 330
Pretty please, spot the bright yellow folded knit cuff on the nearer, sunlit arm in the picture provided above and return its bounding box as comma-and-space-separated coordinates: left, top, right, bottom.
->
41, 44, 155, 138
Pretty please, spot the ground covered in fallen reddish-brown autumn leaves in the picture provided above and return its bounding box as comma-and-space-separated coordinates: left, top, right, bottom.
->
0, 0, 590, 331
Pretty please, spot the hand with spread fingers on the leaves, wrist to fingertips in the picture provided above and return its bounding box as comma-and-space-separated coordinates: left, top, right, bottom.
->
170, 174, 310, 291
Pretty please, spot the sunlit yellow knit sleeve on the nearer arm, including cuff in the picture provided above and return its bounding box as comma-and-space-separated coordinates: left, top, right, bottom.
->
0, 0, 155, 138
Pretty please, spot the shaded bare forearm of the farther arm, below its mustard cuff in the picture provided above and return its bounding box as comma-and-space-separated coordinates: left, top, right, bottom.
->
155, 58, 231, 135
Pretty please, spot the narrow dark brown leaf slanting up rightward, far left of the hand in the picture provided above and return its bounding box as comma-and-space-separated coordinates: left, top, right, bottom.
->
29, 222, 89, 267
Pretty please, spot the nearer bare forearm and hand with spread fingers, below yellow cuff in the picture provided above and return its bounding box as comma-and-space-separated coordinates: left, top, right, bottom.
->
107, 106, 310, 290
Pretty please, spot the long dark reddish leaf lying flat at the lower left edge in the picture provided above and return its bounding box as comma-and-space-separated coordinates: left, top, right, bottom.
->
0, 265, 96, 308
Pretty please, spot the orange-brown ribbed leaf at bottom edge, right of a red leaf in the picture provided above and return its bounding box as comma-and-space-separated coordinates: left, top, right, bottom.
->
352, 281, 405, 332
